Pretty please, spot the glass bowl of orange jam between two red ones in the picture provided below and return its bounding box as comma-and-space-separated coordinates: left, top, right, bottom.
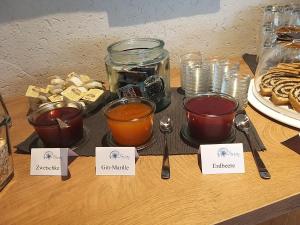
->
103, 97, 155, 147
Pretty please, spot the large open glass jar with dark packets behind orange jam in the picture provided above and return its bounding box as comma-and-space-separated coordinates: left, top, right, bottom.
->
105, 38, 171, 112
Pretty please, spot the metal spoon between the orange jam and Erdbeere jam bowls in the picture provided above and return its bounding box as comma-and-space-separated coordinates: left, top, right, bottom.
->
159, 116, 173, 179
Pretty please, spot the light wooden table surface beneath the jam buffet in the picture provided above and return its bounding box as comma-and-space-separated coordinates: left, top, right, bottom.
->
0, 58, 300, 225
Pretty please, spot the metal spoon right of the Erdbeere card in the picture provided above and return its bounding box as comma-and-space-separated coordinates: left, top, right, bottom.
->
234, 113, 271, 179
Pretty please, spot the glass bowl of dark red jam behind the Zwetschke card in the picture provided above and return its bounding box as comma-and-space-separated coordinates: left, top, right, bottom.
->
28, 102, 83, 148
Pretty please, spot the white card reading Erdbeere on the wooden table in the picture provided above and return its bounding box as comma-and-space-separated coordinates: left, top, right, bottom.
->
200, 143, 245, 174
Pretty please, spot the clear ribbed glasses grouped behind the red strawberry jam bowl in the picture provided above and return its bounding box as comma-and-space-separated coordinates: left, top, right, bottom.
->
180, 53, 251, 109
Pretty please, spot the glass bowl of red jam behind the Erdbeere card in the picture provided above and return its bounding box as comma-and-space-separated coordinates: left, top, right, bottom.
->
183, 93, 238, 143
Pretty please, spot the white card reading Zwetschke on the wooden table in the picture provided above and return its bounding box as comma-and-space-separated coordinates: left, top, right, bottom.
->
30, 148, 68, 176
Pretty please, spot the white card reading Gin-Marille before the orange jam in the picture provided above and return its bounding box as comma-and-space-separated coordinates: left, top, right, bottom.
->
96, 147, 136, 176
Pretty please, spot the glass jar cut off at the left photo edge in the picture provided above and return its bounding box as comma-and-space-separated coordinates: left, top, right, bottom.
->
0, 94, 14, 191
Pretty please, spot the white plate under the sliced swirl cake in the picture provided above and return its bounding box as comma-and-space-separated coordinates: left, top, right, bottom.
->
248, 79, 300, 129
